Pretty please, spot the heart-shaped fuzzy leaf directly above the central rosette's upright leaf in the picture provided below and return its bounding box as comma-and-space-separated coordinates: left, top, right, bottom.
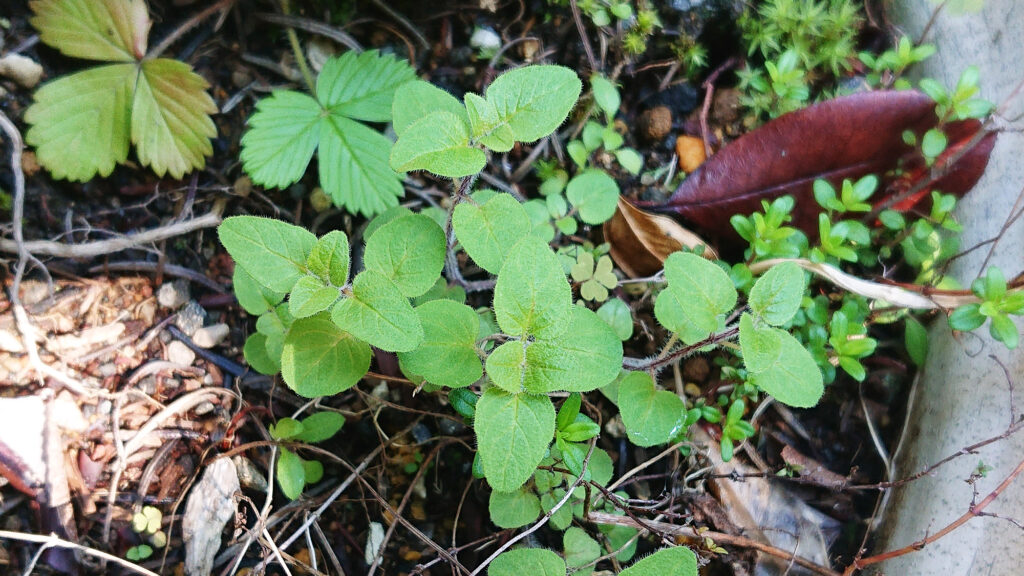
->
452, 194, 531, 275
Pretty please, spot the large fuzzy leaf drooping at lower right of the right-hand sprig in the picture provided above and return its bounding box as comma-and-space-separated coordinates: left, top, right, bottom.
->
737, 314, 824, 408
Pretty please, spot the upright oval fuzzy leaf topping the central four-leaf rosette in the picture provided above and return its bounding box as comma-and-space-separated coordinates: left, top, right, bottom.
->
495, 236, 572, 338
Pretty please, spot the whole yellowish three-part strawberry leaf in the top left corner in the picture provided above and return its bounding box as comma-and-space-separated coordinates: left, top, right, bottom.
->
25, 0, 217, 181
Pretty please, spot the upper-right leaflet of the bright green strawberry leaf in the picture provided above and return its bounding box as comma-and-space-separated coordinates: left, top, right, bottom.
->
316, 50, 416, 122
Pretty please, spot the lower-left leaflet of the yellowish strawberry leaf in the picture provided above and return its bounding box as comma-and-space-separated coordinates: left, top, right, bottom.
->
25, 64, 136, 182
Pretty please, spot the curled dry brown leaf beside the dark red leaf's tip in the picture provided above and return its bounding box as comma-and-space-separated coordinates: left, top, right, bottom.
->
604, 197, 718, 278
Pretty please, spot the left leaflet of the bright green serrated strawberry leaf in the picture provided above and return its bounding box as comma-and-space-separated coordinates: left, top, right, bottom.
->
240, 90, 323, 188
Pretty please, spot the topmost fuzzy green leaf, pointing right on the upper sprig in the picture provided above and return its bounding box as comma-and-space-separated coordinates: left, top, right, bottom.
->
486, 66, 583, 142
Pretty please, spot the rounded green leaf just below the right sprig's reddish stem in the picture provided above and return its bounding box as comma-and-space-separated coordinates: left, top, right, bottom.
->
618, 372, 686, 447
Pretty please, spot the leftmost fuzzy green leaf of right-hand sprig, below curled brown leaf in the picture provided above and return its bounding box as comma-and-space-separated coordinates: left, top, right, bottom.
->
654, 252, 736, 344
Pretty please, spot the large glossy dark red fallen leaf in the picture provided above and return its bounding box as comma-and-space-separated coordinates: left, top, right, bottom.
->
640, 91, 995, 244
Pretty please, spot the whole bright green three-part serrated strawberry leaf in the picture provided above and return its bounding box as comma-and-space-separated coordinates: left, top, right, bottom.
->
241, 50, 415, 216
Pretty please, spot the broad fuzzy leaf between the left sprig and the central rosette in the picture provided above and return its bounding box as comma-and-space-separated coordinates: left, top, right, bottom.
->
398, 299, 483, 387
